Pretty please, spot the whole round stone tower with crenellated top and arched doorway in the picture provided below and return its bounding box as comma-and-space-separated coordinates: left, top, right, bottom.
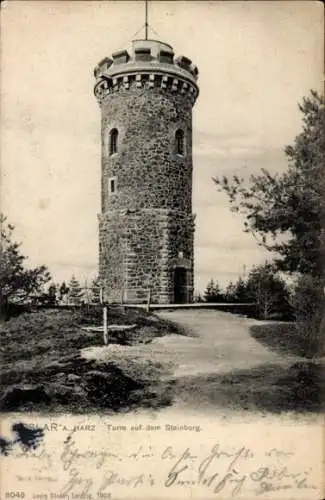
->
95, 40, 198, 304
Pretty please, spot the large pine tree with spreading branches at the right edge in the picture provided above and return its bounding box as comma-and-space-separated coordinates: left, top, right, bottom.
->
214, 91, 325, 278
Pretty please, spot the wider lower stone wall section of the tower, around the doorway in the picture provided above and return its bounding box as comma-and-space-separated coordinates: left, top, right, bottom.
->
100, 209, 193, 303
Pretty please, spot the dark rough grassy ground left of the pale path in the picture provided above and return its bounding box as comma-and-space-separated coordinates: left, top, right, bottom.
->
0, 309, 184, 412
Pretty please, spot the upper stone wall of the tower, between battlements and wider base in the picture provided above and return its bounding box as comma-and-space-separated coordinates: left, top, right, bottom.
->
102, 83, 192, 212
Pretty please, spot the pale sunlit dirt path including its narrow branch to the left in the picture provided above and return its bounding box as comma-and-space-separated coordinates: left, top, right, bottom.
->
85, 310, 294, 378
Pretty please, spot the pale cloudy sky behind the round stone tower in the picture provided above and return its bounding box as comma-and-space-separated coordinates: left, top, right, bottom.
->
0, 0, 324, 293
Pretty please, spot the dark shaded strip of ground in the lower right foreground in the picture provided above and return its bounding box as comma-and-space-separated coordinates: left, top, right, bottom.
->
162, 361, 325, 414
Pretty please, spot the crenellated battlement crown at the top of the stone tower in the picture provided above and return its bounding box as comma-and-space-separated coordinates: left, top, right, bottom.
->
94, 40, 199, 104
